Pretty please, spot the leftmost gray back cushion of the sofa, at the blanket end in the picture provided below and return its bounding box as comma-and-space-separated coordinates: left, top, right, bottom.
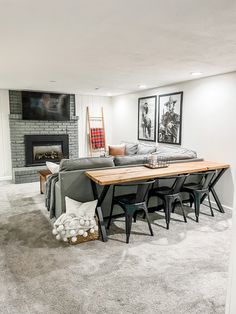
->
59, 157, 114, 171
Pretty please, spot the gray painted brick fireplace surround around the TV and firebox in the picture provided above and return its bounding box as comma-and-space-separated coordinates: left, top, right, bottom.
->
9, 90, 78, 183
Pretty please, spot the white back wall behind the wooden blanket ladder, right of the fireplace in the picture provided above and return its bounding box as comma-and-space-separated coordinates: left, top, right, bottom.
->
75, 95, 113, 157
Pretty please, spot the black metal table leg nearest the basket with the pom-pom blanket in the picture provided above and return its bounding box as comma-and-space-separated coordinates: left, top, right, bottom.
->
90, 180, 110, 242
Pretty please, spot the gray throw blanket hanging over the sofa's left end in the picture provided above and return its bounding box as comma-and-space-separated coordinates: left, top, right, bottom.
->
45, 173, 58, 218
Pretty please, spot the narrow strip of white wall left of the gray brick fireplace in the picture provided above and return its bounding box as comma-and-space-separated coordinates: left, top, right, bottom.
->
0, 90, 11, 180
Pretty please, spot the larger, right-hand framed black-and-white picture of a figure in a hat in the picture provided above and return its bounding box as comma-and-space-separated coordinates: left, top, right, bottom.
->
158, 92, 183, 145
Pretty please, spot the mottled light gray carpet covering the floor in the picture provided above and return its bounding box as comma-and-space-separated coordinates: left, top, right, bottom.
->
0, 182, 231, 314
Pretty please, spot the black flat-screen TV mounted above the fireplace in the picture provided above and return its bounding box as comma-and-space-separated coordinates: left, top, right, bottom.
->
21, 91, 70, 121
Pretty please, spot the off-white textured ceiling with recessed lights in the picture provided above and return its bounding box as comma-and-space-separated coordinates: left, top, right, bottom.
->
0, 0, 236, 95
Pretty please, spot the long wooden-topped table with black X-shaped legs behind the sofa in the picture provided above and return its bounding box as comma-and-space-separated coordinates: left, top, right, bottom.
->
85, 161, 230, 242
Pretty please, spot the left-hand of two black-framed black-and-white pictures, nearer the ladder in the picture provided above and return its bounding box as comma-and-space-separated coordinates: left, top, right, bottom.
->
138, 96, 157, 142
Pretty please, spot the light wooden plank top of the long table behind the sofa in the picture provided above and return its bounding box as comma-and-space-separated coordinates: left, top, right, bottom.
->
85, 161, 230, 185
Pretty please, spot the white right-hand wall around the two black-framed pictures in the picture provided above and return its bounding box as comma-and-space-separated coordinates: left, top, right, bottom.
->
112, 73, 236, 208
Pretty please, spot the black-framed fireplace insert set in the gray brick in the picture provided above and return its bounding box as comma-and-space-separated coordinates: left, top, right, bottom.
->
25, 134, 69, 166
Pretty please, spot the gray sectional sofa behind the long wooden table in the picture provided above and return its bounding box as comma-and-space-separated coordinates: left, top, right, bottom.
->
48, 143, 202, 217
